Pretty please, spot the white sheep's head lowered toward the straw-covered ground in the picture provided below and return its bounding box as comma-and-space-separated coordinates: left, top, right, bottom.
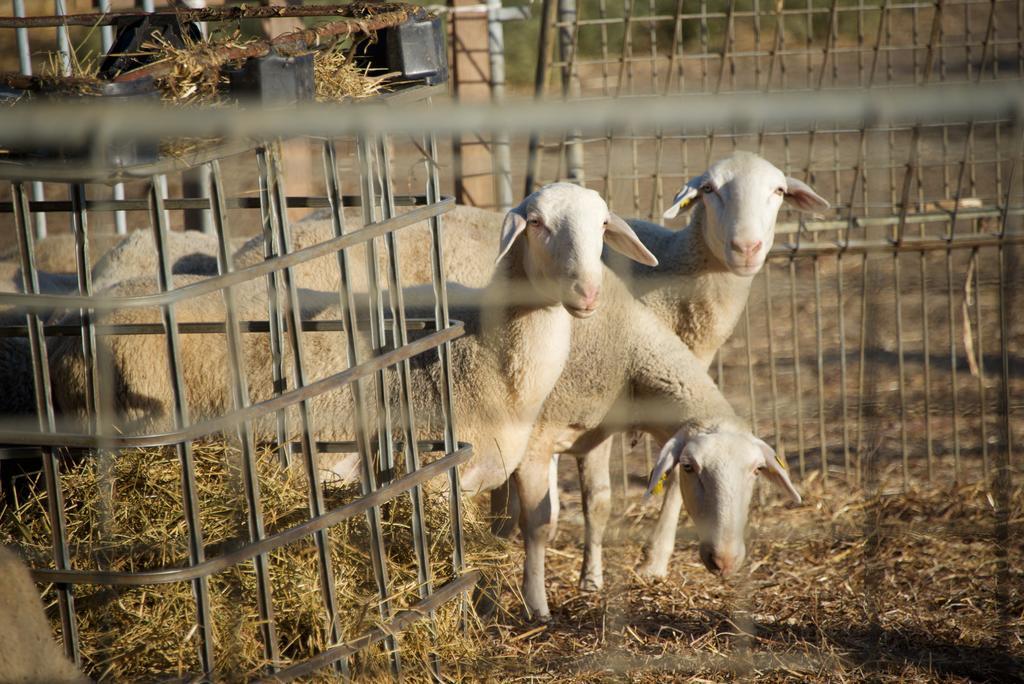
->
648, 429, 800, 576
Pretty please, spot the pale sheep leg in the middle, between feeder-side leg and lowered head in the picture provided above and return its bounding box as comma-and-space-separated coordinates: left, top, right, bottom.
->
577, 437, 611, 592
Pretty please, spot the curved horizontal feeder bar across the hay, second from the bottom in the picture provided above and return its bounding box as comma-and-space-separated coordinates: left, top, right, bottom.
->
32, 442, 473, 587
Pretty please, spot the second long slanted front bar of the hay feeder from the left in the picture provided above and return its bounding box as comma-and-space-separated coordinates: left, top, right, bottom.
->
150, 177, 214, 674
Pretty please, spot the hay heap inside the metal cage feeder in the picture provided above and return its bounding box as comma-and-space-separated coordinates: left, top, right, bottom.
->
0, 442, 508, 681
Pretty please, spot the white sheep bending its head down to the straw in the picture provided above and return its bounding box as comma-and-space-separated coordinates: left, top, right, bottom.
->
513, 270, 799, 618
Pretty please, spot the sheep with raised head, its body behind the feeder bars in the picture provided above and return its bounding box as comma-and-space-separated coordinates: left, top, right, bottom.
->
53, 183, 656, 493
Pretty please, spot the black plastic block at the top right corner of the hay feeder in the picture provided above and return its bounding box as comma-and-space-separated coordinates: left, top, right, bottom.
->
357, 12, 449, 85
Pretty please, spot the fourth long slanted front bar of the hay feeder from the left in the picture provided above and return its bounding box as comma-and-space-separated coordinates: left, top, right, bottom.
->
263, 143, 341, 655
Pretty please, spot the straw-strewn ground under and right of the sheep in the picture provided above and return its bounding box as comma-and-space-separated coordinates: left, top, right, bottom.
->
471, 456, 1024, 683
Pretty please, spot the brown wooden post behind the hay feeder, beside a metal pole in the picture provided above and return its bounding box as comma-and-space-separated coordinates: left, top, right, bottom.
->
449, 0, 496, 208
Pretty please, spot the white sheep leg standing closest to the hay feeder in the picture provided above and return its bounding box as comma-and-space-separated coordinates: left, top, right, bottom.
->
513, 450, 551, 621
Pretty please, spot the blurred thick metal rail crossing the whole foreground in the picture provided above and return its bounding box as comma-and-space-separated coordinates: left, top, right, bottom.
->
0, 82, 1024, 147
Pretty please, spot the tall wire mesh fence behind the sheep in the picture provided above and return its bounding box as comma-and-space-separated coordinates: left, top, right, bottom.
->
527, 0, 1024, 497
